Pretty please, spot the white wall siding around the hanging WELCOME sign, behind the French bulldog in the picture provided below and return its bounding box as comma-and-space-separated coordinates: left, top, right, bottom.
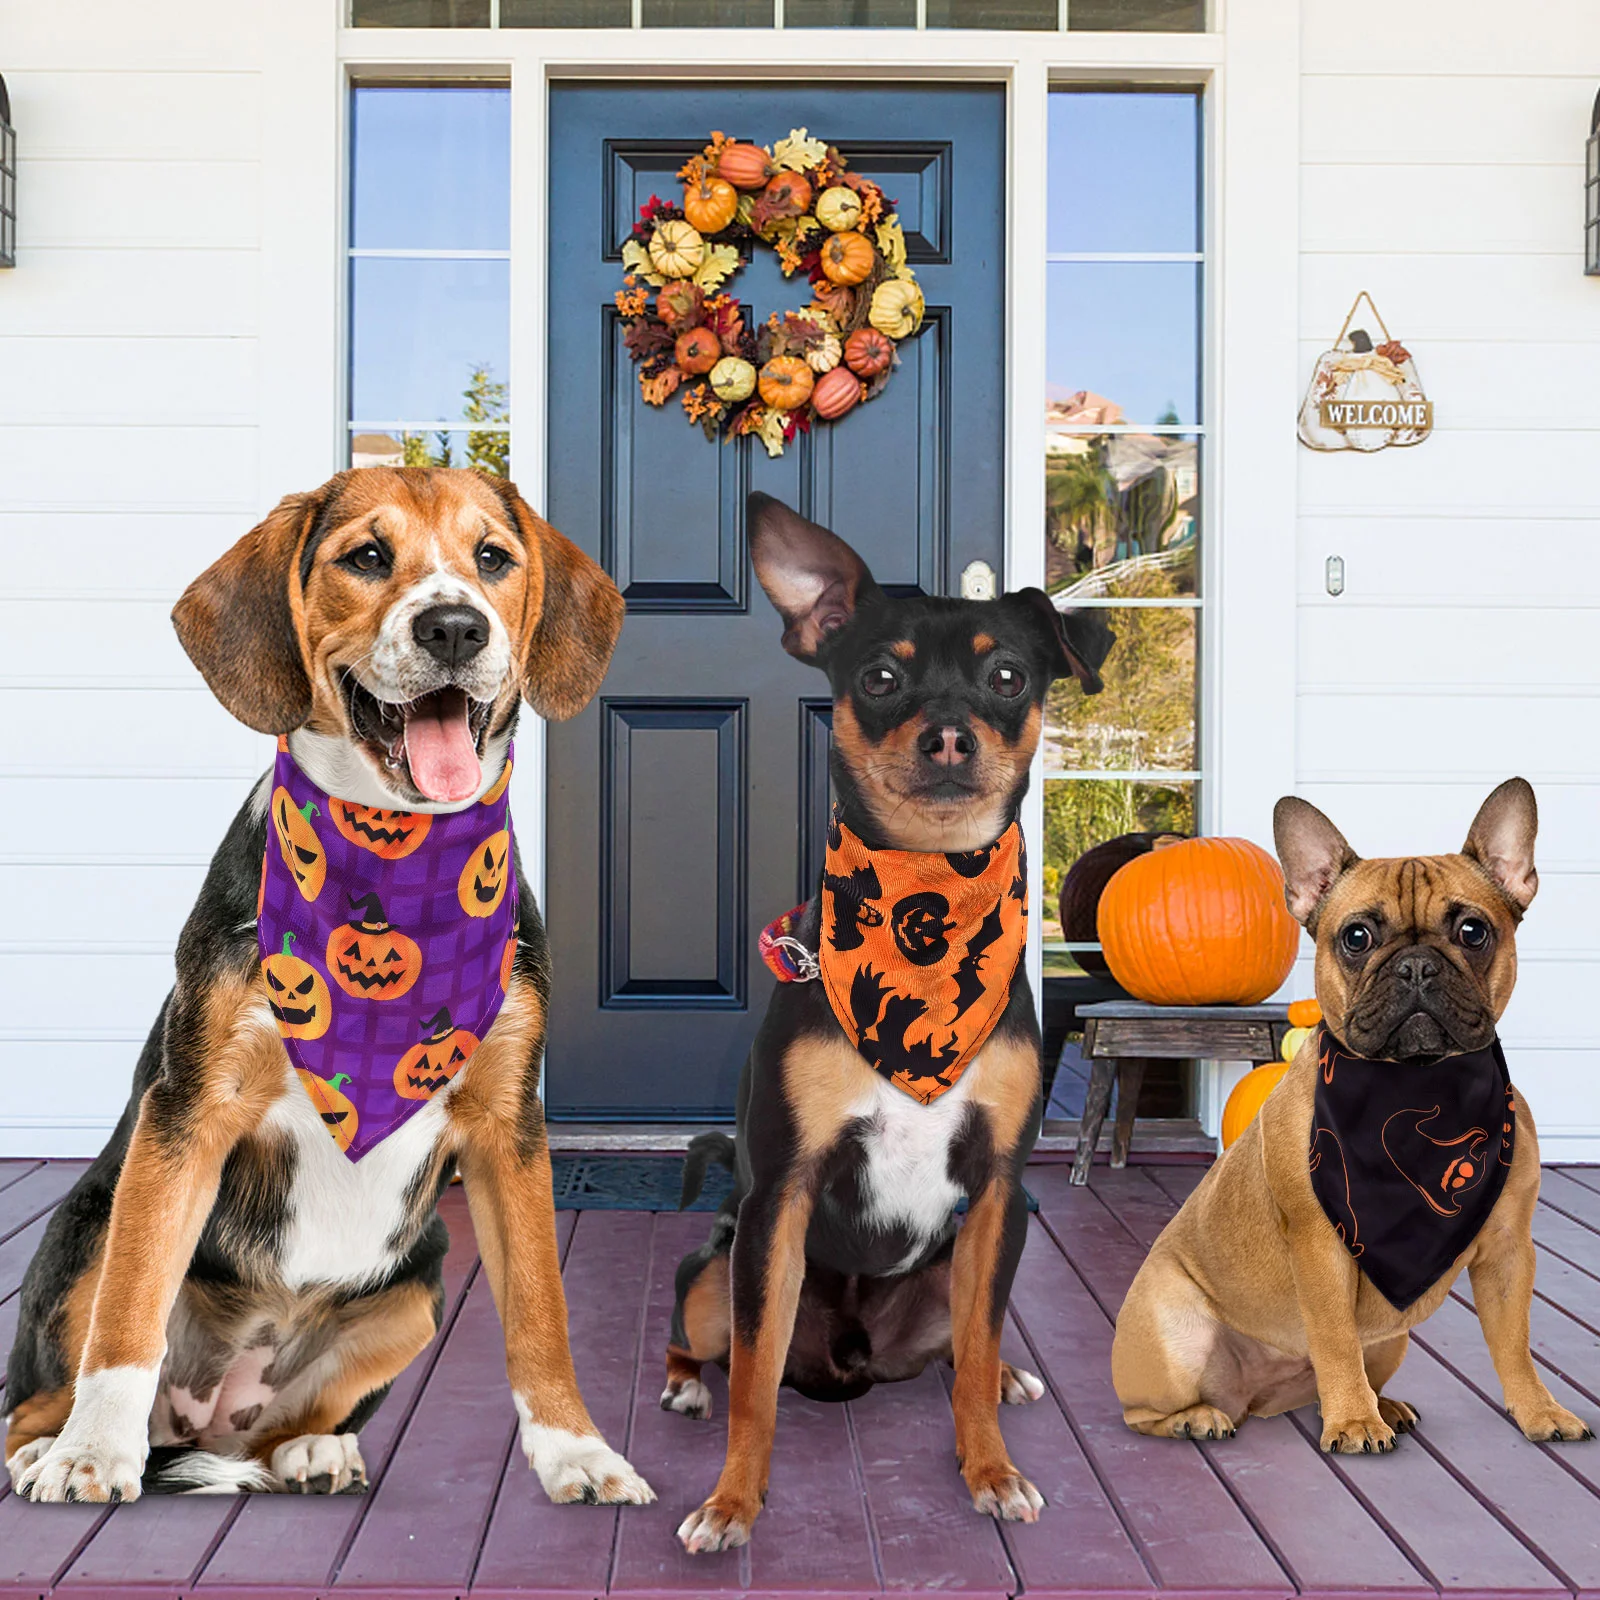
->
1296, 0, 1600, 1160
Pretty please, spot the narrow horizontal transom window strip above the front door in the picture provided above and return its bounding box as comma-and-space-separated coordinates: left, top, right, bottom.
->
349, 0, 1206, 34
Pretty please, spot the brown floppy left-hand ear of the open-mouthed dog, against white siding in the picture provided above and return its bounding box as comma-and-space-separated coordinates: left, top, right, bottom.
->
173, 478, 324, 733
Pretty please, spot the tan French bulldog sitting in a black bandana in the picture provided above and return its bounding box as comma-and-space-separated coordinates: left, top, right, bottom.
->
1112, 778, 1592, 1453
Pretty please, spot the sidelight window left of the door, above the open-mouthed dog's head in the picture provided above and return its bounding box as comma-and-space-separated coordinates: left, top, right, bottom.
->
349, 83, 510, 477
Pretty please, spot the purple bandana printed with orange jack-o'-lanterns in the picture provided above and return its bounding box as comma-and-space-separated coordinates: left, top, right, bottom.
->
258, 739, 517, 1162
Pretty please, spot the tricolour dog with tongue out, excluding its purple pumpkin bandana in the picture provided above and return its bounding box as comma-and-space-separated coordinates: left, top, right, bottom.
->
6, 469, 654, 1502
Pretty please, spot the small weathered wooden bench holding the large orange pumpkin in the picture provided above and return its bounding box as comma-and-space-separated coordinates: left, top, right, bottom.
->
1072, 1000, 1290, 1184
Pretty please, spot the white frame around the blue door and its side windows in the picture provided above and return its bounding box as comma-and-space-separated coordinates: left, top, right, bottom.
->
261, 0, 1299, 1130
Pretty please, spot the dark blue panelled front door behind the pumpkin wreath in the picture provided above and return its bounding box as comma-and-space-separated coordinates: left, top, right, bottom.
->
546, 83, 1005, 1122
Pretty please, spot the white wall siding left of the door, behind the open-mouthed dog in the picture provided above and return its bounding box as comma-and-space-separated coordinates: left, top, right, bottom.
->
0, 25, 276, 1155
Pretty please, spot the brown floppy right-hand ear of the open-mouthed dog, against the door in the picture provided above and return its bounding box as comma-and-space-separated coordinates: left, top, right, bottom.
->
490, 478, 626, 722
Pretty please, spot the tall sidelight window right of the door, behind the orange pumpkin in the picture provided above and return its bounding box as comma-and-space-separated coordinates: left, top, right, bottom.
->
1043, 90, 1205, 976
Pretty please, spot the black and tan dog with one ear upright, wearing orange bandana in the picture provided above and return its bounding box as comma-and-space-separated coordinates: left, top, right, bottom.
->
661, 494, 1110, 1550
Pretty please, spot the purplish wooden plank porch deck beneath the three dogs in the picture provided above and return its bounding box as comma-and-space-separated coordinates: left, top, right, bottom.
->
0, 1162, 1600, 1600
